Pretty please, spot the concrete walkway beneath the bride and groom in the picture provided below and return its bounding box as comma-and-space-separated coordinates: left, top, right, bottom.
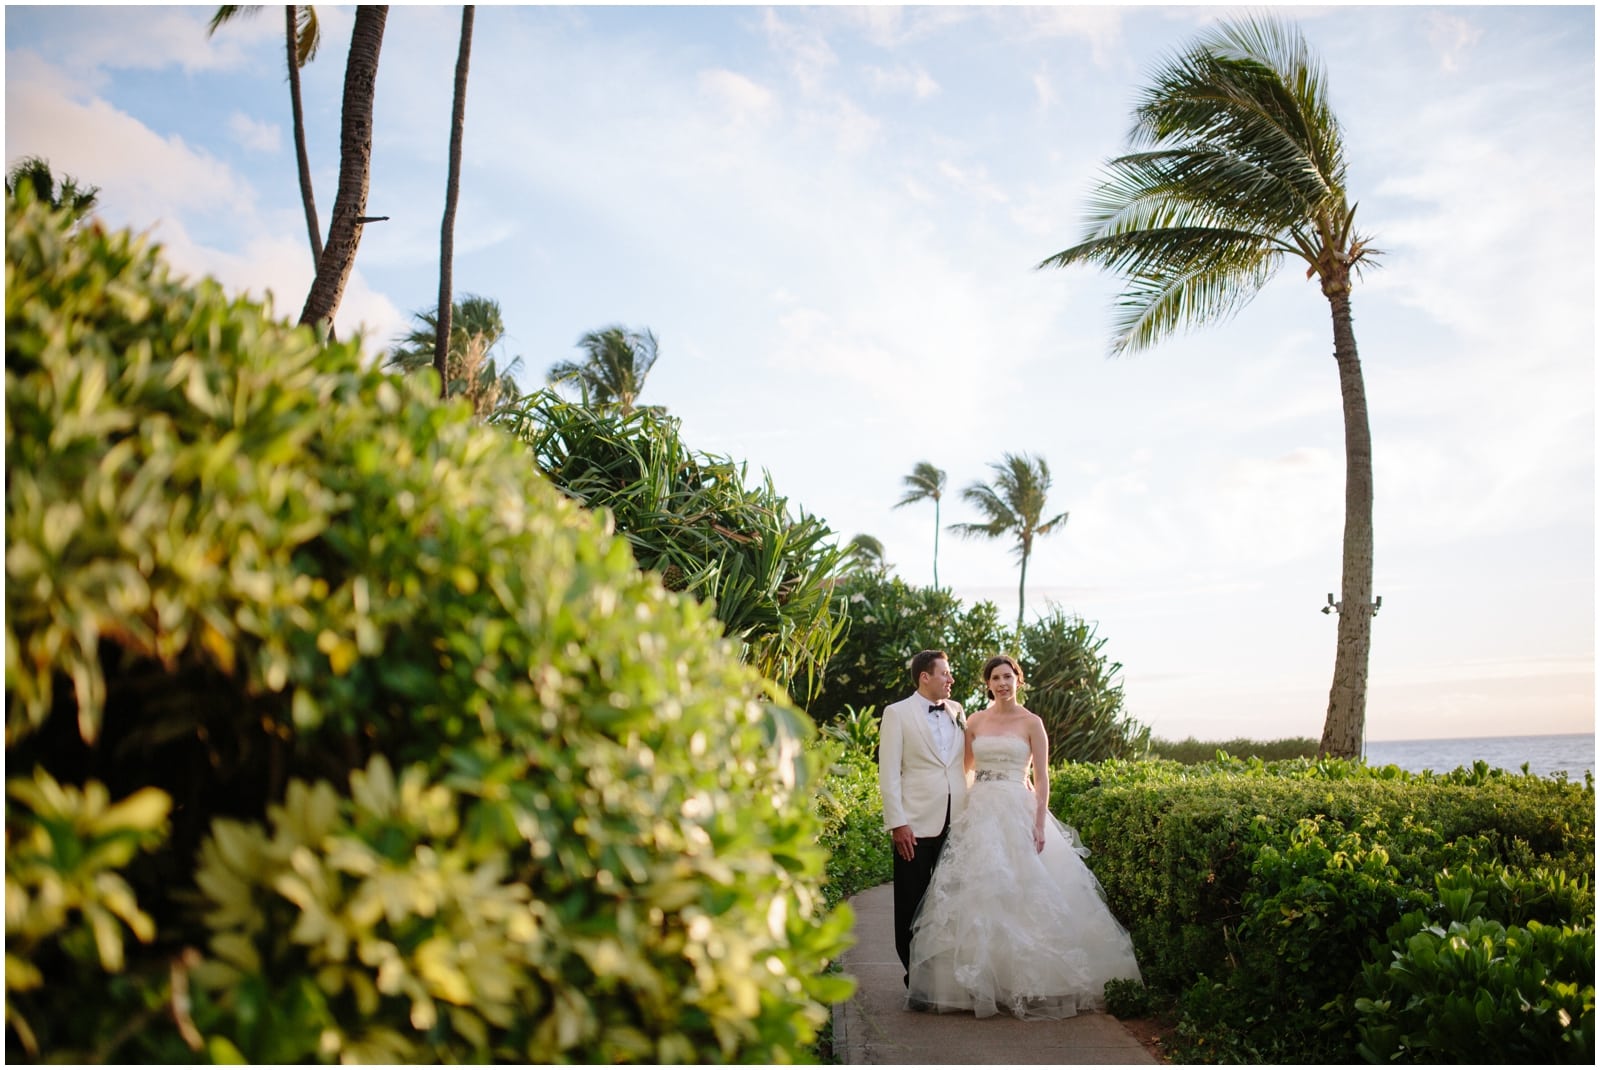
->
834, 884, 1155, 1065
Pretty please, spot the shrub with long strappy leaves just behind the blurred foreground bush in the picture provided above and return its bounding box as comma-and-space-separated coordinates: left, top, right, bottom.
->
494, 390, 845, 697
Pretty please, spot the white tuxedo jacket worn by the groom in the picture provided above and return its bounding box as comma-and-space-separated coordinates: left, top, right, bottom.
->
878, 694, 966, 836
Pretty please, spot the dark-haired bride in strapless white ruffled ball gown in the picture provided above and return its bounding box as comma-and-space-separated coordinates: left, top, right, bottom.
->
907, 654, 1139, 1019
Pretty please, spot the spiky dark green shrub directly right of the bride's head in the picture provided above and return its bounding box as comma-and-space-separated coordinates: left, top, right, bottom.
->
1021, 608, 1150, 761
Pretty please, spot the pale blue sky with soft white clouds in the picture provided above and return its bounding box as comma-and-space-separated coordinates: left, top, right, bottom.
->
5, 5, 1597, 741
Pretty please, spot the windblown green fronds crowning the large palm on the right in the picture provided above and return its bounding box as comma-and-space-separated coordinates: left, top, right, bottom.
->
1038, 18, 1376, 353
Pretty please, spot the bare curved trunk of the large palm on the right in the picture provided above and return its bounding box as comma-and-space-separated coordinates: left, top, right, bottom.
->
1317, 285, 1373, 758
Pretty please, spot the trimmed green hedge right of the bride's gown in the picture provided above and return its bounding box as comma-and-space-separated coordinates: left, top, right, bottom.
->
1051, 760, 1594, 1062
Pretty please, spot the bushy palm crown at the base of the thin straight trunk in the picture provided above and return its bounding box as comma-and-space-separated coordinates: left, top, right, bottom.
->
384, 294, 522, 417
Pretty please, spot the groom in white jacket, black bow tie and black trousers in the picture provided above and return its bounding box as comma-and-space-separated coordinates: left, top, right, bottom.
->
878, 651, 966, 984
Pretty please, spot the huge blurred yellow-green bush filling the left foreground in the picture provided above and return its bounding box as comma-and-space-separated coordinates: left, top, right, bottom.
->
5, 203, 850, 1062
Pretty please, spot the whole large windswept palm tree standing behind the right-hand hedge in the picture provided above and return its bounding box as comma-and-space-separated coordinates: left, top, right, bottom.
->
1040, 12, 1378, 757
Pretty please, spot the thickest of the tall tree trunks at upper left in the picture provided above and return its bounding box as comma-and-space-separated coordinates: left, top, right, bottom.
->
299, 5, 389, 326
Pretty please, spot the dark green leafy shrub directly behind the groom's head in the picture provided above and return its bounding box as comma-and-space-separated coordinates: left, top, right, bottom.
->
806, 571, 1005, 725
